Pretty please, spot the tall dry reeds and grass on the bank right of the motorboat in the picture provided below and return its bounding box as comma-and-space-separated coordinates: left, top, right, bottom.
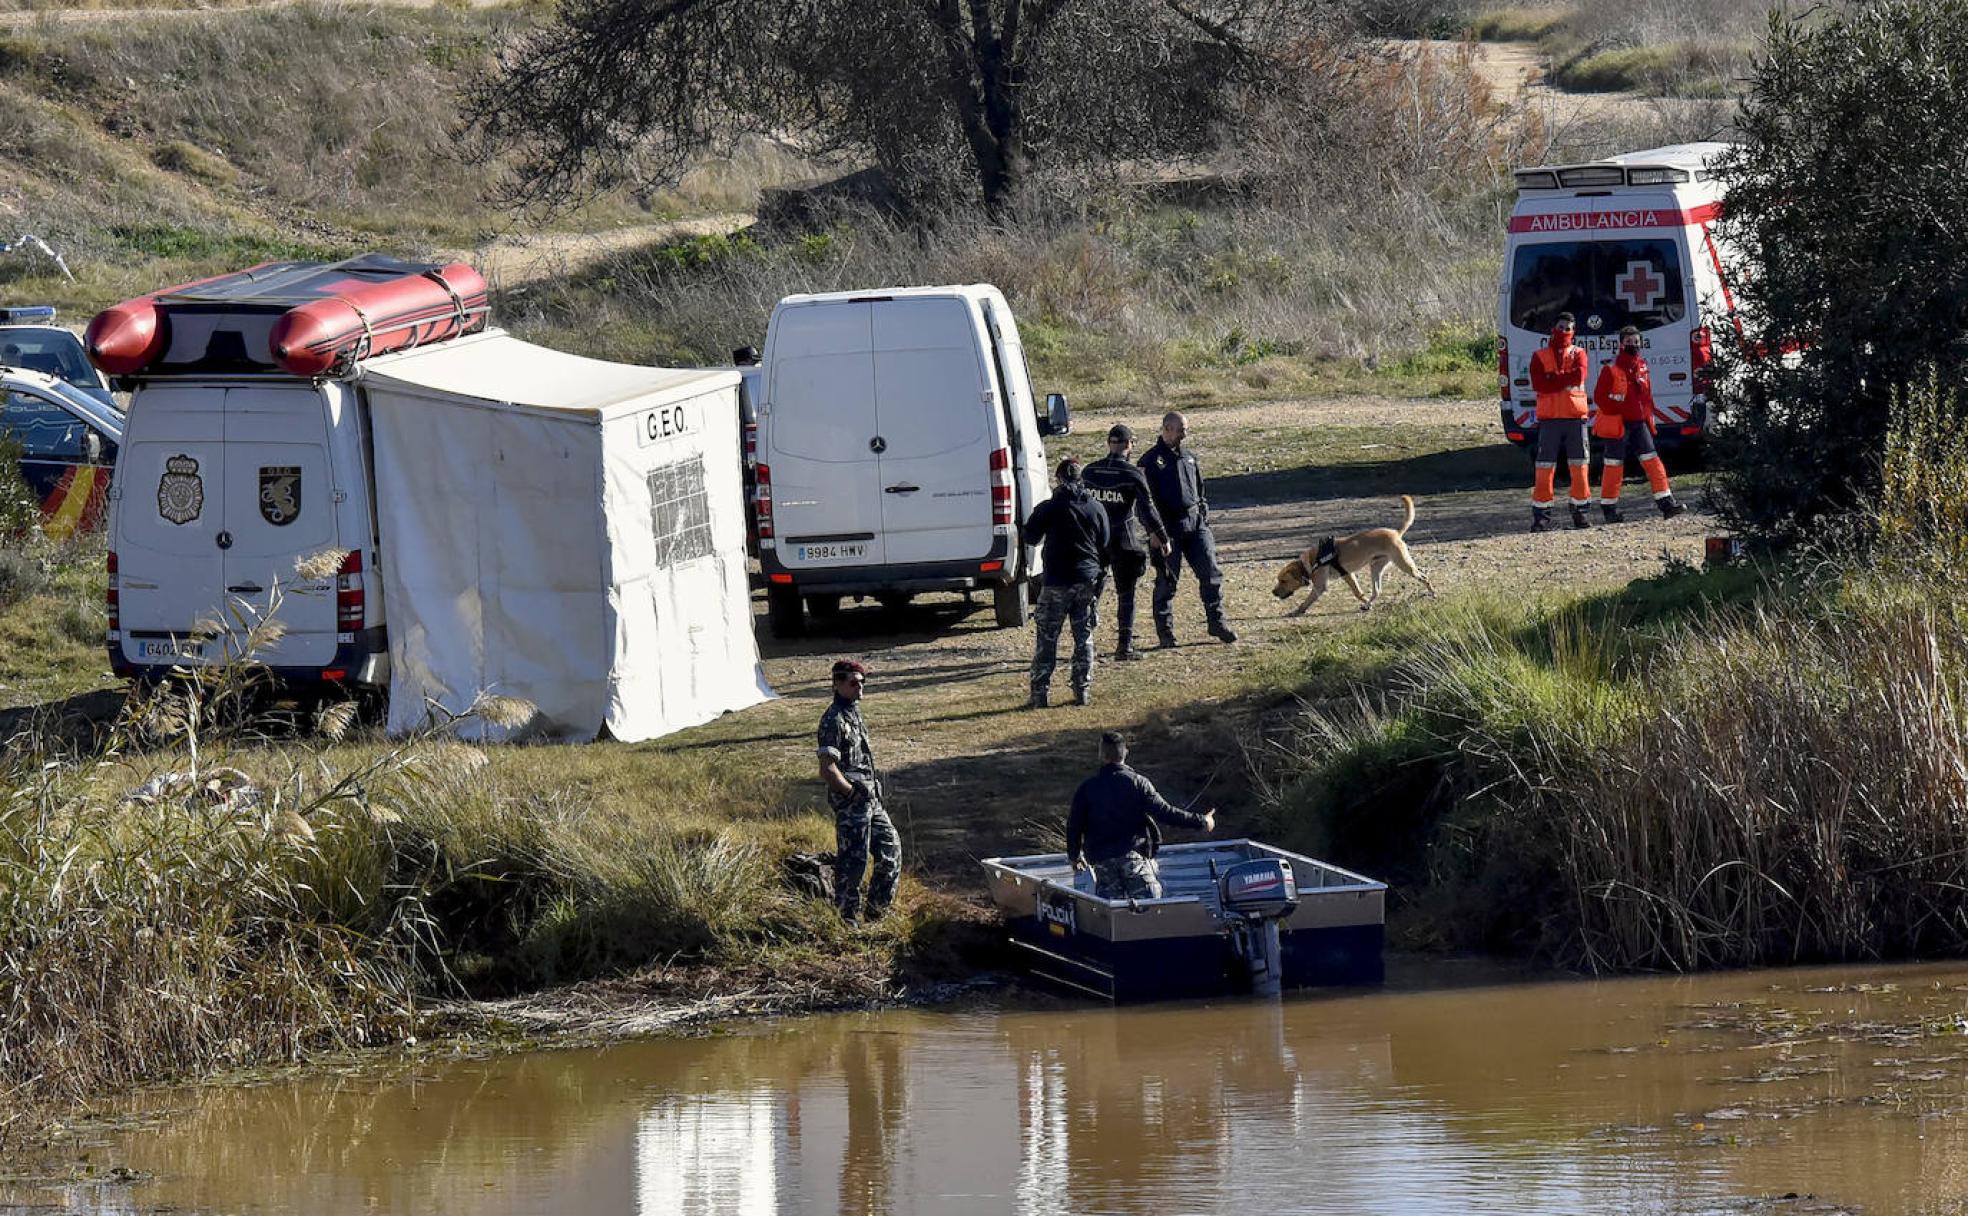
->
1267, 571, 1968, 970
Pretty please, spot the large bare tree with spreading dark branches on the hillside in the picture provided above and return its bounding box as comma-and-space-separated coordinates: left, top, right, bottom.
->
452, 0, 1334, 214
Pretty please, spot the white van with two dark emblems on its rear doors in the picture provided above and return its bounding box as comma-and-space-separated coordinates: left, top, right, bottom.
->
108, 376, 390, 689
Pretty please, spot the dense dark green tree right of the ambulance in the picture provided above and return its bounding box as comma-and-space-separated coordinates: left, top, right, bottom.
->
1716, 0, 1968, 545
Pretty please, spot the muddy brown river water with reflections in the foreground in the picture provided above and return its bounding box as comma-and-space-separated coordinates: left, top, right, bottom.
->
6, 962, 1968, 1216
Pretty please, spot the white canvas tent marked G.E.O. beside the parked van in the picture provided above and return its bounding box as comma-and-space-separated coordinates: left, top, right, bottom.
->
362, 331, 771, 742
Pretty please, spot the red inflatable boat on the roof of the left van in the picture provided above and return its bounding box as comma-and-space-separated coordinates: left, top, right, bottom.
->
83, 254, 490, 378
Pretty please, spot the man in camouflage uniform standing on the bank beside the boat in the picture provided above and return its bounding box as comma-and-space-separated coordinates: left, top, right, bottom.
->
821, 659, 901, 925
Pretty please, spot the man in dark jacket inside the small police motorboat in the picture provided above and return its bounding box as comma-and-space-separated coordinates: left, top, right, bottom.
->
1067, 730, 1216, 899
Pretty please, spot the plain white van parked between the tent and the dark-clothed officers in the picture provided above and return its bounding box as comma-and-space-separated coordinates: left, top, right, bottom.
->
756, 285, 1071, 636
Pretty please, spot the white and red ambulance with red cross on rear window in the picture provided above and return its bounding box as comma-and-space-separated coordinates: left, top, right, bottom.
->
1496, 144, 1740, 449
